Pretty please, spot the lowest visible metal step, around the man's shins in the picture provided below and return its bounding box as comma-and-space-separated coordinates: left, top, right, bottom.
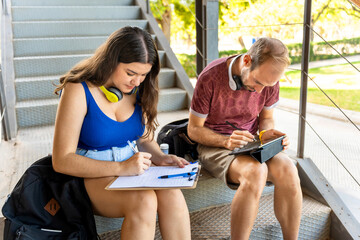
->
190, 194, 331, 240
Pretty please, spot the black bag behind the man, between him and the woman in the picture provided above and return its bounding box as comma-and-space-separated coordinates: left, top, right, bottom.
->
157, 118, 198, 160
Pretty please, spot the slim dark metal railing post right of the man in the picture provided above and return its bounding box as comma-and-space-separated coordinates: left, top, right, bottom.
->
297, 0, 311, 158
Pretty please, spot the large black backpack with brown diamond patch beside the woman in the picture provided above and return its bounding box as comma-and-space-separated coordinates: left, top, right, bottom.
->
2, 156, 98, 240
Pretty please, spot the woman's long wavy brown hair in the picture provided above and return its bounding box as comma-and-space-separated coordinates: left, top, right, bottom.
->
54, 27, 160, 138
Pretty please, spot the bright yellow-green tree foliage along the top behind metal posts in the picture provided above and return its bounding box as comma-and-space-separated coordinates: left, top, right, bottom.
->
150, 0, 360, 48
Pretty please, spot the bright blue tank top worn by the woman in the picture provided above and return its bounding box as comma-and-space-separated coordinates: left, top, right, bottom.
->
78, 82, 145, 151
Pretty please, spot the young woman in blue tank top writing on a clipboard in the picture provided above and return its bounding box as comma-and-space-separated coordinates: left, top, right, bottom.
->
53, 27, 190, 240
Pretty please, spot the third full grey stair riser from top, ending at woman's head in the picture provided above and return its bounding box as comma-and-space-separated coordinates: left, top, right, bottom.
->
13, 35, 156, 57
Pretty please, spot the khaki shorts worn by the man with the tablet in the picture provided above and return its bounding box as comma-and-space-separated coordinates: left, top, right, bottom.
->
197, 144, 239, 190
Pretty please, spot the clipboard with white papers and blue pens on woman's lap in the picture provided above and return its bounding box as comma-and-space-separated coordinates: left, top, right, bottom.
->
105, 162, 201, 190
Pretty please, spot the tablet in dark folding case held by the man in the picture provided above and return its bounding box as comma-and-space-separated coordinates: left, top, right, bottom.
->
229, 136, 285, 163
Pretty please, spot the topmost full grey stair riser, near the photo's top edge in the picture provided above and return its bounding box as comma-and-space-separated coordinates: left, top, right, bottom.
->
11, 6, 141, 21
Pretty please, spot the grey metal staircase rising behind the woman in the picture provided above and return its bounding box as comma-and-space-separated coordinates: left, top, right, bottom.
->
11, 0, 192, 128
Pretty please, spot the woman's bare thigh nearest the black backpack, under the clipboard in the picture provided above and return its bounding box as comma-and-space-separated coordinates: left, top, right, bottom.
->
84, 177, 157, 217
